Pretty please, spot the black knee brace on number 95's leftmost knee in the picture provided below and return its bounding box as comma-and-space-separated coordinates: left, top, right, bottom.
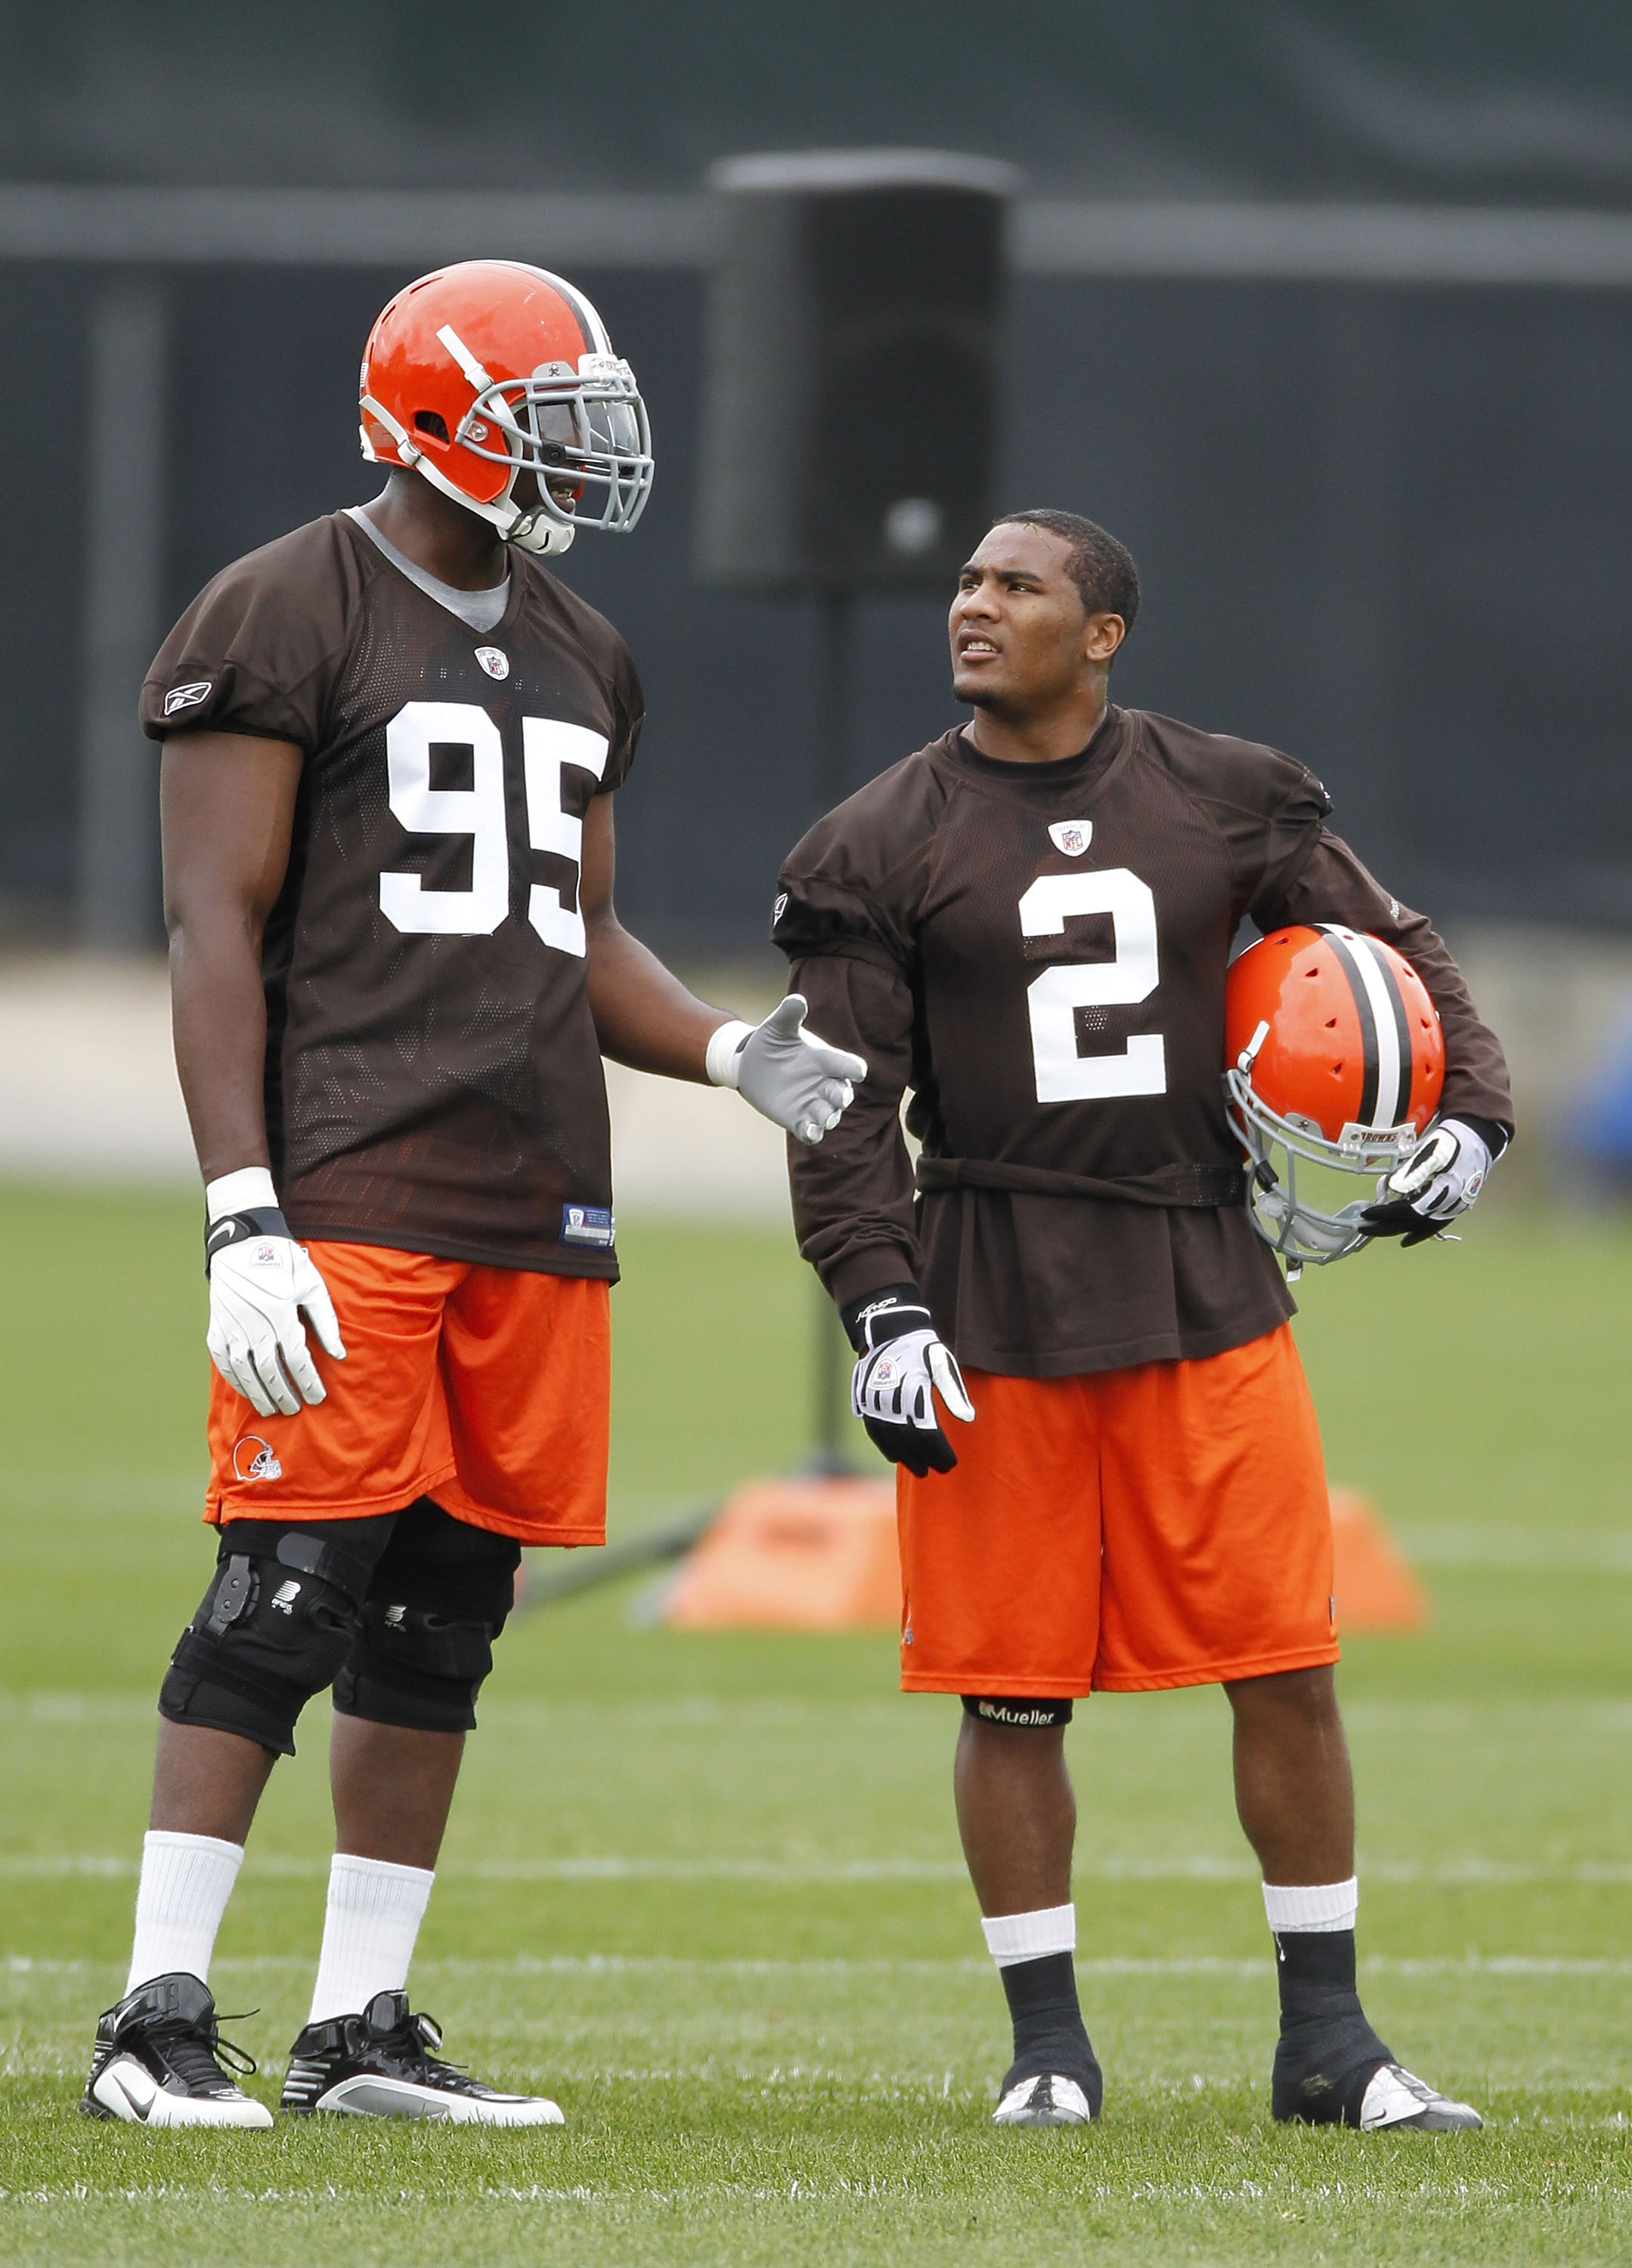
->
159, 1522, 367, 1755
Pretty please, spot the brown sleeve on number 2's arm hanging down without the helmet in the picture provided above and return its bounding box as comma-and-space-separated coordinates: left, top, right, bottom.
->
789, 953, 918, 1306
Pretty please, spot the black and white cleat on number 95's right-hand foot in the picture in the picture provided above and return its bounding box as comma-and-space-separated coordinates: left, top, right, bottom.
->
279, 1991, 565, 2125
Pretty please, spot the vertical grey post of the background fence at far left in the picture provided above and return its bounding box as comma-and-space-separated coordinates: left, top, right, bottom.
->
77, 277, 168, 953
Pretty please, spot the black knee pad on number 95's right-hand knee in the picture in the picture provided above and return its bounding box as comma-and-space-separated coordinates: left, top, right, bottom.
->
333, 1497, 522, 1733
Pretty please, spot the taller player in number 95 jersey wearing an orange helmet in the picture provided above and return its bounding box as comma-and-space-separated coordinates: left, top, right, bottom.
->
84, 261, 866, 2127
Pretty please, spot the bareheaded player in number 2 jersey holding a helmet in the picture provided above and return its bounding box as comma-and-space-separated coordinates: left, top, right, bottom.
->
773, 508, 1512, 2132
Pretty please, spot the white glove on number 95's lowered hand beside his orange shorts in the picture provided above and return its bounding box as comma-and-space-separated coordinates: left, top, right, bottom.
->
204, 1166, 345, 1418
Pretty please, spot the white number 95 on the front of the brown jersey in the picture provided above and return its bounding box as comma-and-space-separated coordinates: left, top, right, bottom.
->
381, 701, 608, 959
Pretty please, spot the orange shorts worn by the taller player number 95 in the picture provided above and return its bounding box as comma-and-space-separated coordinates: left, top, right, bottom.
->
204, 1238, 612, 1545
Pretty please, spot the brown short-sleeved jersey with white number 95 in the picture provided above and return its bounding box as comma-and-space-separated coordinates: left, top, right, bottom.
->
143, 513, 642, 1277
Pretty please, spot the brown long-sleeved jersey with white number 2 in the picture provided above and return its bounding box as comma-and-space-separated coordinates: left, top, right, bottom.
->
773, 708, 1512, 1377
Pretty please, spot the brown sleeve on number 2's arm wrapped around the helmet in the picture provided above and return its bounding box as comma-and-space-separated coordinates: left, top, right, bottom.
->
1251, 828, 1514, 1136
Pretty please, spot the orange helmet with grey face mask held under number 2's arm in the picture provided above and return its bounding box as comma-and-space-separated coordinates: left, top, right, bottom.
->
1224, 923, 1444, 1275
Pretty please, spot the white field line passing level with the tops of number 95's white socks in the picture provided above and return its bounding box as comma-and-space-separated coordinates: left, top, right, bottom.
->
0, 1851, 1632, 1889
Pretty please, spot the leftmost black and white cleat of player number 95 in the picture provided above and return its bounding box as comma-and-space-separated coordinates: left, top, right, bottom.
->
79, 1969, 272, 2127
